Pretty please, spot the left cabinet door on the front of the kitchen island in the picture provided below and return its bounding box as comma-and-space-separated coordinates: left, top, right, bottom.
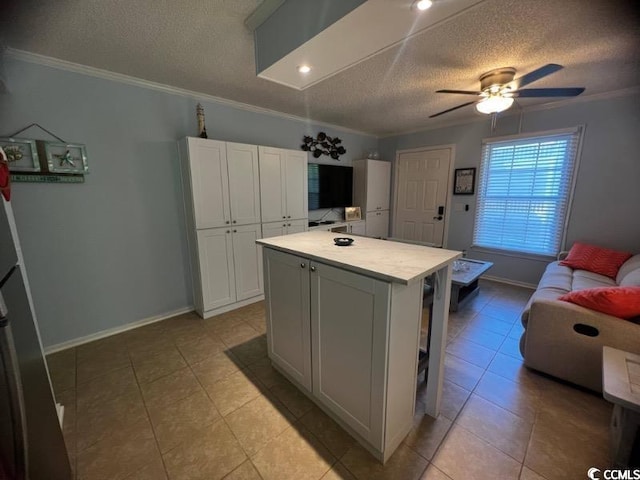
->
263, 248, 311, 391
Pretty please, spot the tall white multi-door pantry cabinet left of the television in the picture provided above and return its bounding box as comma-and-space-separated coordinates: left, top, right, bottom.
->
178, 137, 307, 318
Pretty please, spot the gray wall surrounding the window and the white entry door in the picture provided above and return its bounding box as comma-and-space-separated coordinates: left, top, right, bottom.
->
380, 93, 640, 284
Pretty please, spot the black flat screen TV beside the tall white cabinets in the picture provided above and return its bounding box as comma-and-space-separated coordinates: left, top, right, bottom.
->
307, 163, 353, 210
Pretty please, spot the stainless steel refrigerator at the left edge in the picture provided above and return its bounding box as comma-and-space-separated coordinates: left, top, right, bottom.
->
0, 197, 71, 480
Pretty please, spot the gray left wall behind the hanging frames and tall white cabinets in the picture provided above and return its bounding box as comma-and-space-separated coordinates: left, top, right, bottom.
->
0, 59, 377, 346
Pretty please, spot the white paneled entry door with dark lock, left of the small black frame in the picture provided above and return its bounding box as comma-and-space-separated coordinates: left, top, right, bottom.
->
393, 148, 452, 246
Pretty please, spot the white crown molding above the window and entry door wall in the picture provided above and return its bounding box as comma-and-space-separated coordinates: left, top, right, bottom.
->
378, 86, 640, 140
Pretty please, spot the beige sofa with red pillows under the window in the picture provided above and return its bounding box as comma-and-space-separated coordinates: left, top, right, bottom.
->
520, 254, 640, 392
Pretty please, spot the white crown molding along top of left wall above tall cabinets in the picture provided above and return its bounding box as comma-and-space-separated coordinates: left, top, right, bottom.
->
5, 47, 378, 138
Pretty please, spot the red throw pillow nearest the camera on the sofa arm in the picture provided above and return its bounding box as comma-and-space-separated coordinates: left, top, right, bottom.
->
558, 287, 640, 320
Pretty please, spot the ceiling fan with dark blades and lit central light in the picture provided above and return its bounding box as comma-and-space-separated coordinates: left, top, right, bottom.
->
429, 63, 584, 118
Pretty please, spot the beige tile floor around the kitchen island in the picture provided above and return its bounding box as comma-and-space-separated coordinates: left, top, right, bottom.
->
48, 281, 611, 480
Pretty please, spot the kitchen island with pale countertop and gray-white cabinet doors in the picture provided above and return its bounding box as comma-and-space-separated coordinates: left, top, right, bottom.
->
257, 231, 461, 463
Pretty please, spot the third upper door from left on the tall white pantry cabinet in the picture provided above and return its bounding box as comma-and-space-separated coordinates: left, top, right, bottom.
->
258, 147, 287, 222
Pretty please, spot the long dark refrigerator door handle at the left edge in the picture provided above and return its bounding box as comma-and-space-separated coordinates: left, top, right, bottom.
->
0, 316, 29, 480
